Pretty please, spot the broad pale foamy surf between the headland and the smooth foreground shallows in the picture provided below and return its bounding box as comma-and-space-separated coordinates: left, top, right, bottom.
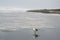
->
0, 13, 60, 32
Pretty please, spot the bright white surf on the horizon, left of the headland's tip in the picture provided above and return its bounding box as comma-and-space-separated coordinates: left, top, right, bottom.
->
0, 7, 28, 13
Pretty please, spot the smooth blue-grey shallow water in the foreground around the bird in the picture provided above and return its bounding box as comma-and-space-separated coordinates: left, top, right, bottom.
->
0, 28, 60, 40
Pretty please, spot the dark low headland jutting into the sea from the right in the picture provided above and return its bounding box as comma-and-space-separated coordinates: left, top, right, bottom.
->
27, 9, 60, 14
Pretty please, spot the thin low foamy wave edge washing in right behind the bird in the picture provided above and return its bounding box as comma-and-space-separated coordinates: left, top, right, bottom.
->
0, 26, 56, 32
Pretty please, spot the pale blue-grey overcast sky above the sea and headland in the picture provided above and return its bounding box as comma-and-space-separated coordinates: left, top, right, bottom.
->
0, 0, 60, 9
